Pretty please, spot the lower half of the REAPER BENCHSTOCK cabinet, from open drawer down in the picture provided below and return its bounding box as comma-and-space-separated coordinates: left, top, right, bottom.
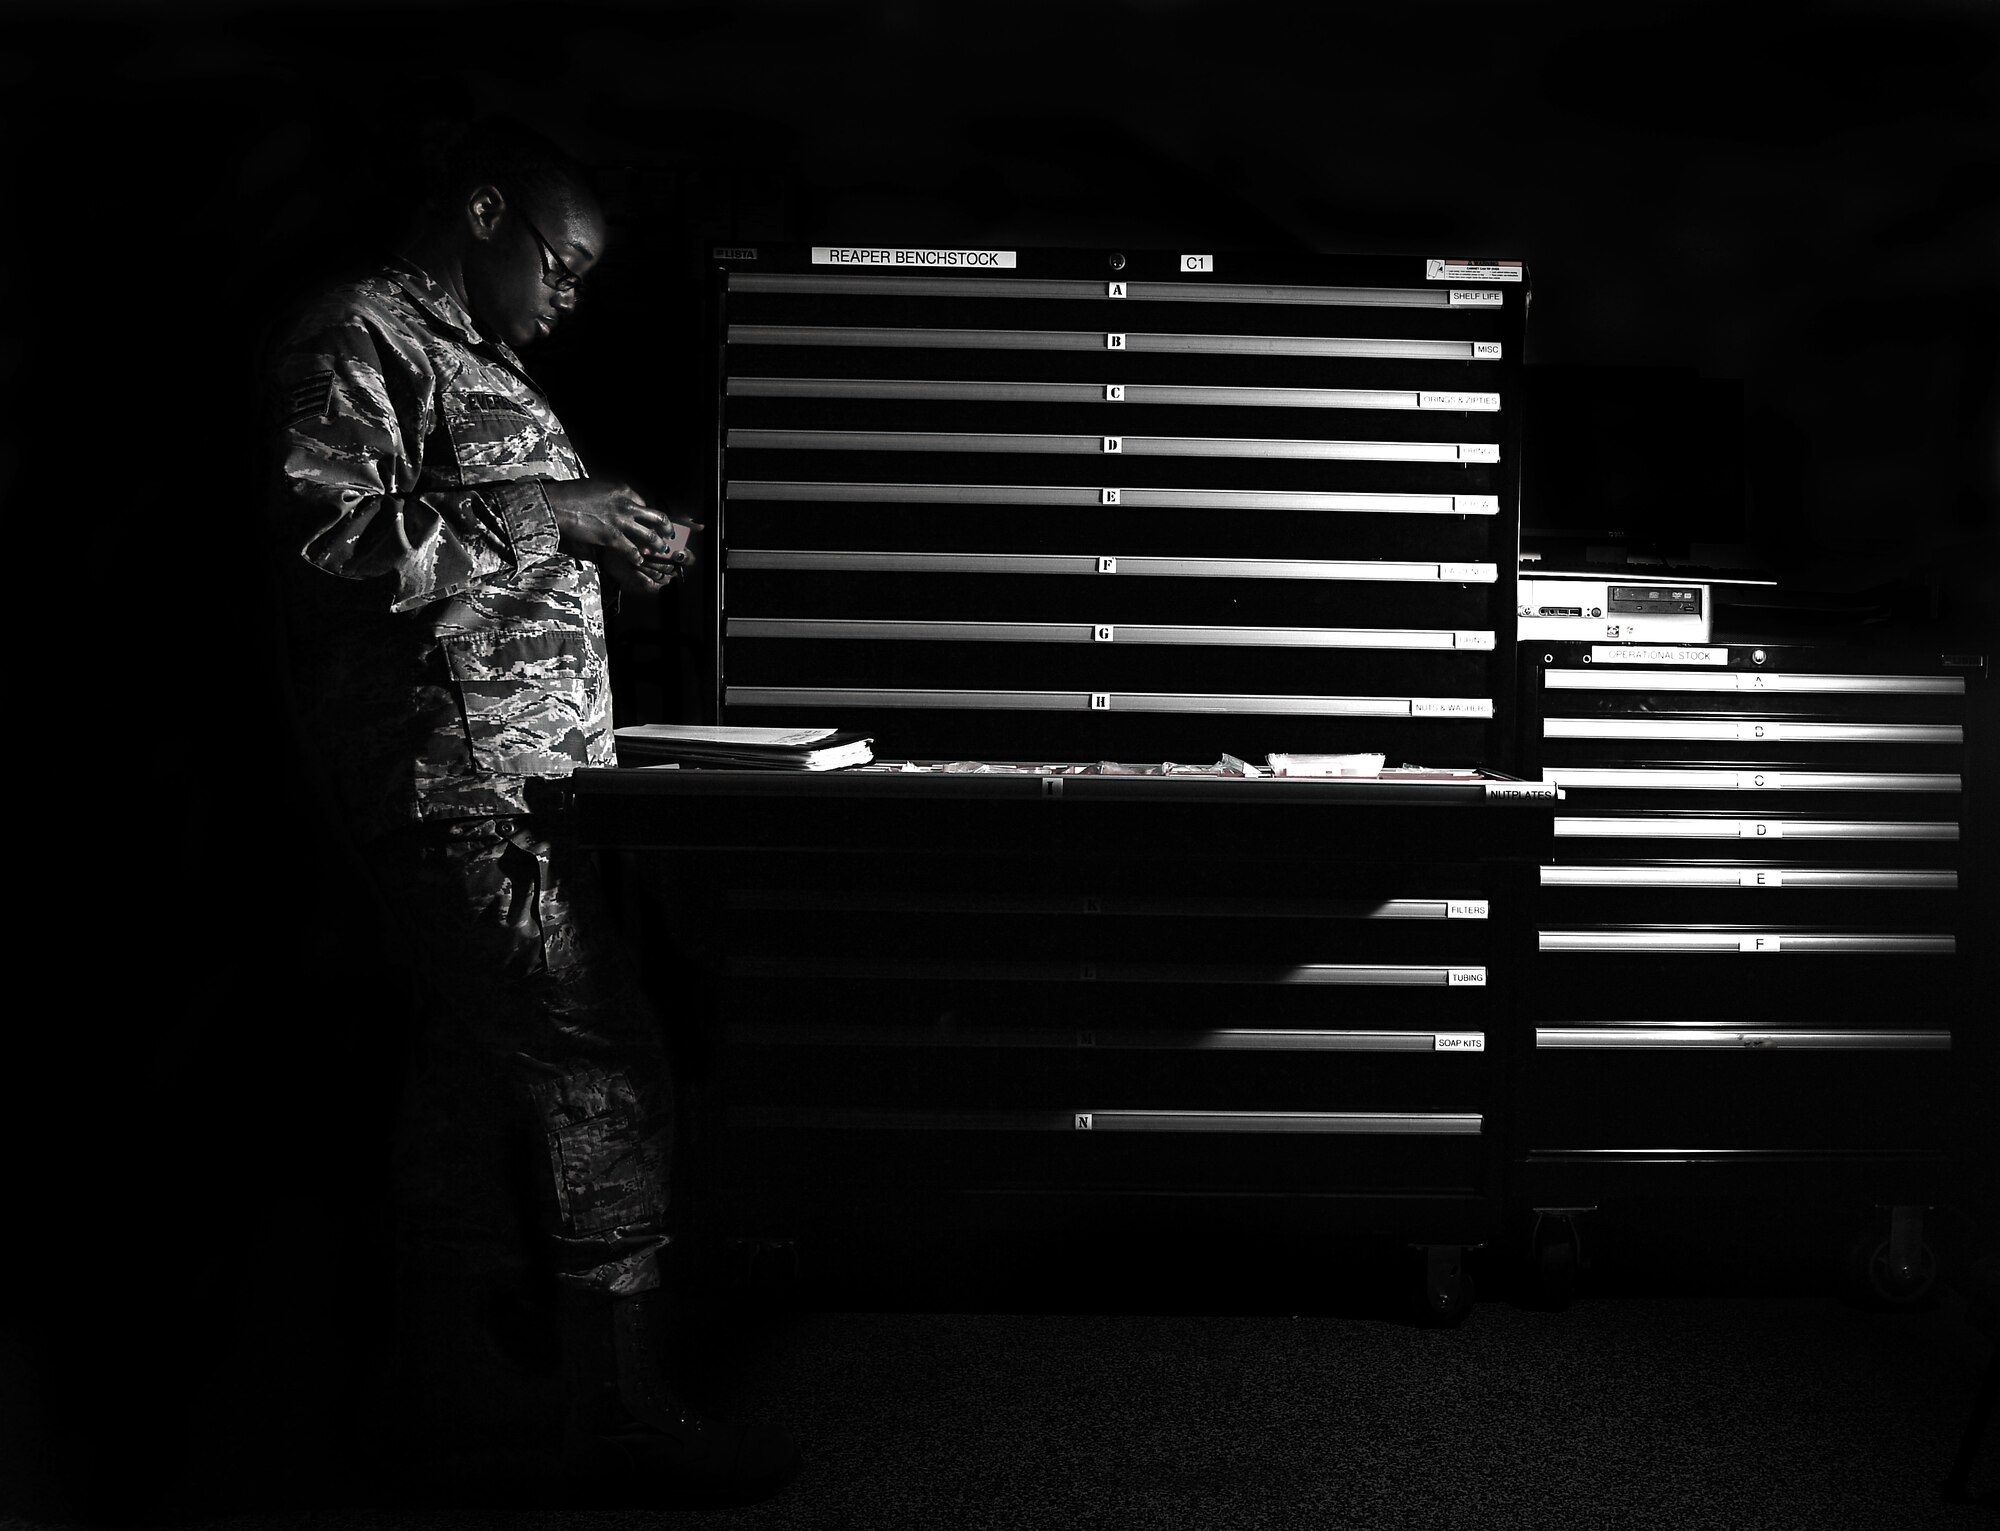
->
570, 769, 1548, 1319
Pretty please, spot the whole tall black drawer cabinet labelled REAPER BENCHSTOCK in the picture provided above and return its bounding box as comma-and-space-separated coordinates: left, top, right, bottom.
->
578, 248, 1548, 1315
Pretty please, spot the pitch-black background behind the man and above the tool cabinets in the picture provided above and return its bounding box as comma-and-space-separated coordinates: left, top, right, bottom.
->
0, 0, 2000, 1511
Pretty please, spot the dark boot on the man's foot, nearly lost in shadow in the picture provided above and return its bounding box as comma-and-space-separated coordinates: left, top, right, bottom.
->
562, 1293, 798, 1509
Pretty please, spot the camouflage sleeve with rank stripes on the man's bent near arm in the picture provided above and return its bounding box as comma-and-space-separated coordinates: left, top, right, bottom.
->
272, 312, 560, 612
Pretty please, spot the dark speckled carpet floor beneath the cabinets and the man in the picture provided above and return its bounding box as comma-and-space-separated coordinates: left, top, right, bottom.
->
4, 1263, 2000, 1531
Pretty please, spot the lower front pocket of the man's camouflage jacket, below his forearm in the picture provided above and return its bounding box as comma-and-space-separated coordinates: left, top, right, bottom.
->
442, 628, 602, 775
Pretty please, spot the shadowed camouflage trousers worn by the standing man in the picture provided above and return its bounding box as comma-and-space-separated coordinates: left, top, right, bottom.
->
366, 815, 674, 1295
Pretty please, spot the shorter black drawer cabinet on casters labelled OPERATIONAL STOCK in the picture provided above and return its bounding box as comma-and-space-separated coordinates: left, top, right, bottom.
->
1512, 644, 1980, 1301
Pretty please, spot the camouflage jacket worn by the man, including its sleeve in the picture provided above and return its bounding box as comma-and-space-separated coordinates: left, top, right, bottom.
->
270, 266, 616, 839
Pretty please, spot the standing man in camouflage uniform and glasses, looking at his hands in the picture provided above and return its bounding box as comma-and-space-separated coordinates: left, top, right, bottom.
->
270, 128, 790, 1495
